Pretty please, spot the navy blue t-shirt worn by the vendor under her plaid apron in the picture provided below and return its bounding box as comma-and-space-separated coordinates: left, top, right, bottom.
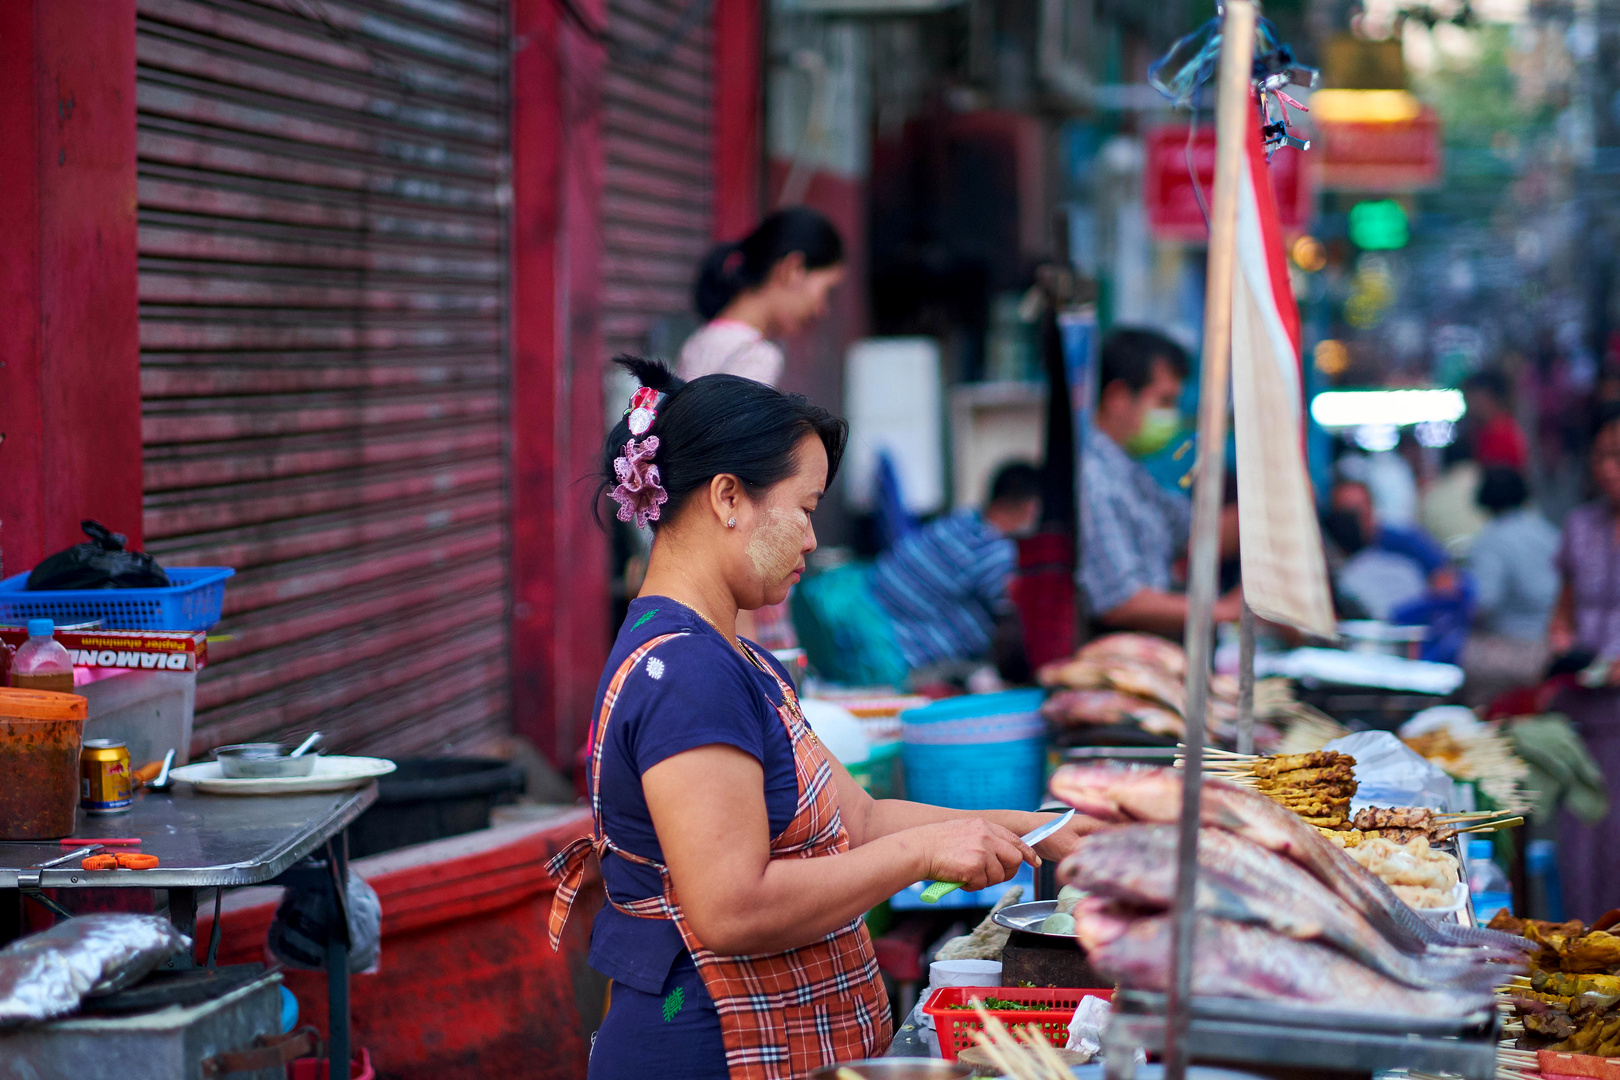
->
590, 596, 799, 994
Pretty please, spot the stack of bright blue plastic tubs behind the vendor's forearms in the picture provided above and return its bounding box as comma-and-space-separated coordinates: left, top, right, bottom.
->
901, 690, 1047, 810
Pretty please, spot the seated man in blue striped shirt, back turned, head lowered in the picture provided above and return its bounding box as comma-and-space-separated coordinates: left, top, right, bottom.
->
870, 461, 1040, 670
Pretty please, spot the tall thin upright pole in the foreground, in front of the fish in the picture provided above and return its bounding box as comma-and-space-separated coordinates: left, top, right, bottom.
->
1165, 0, 1257, 1080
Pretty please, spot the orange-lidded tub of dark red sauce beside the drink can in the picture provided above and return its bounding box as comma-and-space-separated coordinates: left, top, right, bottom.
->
0, 687, 89, 840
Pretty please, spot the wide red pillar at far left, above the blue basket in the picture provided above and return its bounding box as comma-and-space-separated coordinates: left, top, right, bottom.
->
0, 0, 141, 573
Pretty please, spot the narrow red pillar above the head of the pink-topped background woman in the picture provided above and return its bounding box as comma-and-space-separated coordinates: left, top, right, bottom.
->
713, 0, 765, 240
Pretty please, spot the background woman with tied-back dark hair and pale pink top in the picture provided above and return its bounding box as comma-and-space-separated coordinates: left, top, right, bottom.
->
680, 206, 844, 387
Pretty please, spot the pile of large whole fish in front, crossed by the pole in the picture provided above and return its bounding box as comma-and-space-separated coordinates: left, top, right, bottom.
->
1051, 766, 1526, 1017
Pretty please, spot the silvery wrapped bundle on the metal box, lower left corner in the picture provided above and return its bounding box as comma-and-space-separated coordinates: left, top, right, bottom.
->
0, 912, 191, 1025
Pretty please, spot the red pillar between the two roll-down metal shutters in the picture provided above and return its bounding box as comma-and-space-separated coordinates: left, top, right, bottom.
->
509, 0, 609, 769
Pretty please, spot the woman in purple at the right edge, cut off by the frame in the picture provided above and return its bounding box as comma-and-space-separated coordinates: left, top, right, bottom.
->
1549, 403, 1620, 921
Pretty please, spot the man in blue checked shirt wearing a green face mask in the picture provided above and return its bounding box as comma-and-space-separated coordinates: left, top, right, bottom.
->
1081, 330, 1243, 638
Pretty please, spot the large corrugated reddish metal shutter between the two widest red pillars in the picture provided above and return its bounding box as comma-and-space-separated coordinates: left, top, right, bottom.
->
136, 0, 509, 755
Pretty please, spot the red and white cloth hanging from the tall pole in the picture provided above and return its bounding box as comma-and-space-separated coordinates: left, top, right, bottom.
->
1231, 106, 1335, 638
